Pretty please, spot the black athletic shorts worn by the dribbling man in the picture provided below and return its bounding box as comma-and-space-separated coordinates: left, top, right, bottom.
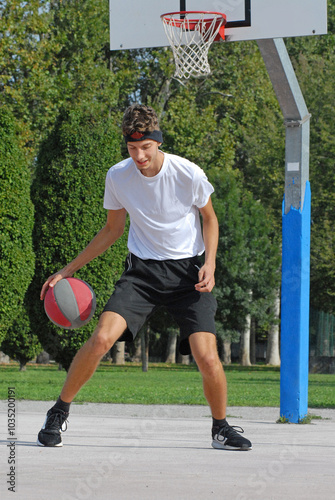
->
104, 254, 217, 354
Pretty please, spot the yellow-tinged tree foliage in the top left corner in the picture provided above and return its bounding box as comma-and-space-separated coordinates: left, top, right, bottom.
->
0, 0, 53, 156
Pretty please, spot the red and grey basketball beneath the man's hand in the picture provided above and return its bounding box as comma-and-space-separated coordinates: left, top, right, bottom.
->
44, 278, 96, 330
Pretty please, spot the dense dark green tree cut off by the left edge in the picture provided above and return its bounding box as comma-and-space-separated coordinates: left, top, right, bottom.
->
0, 108, 34, 342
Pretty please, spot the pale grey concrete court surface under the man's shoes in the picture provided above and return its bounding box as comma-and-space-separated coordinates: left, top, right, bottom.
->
0, 401, 335, 500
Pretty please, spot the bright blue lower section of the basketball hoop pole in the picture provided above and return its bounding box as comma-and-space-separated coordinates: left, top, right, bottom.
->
280, 181, 311, 423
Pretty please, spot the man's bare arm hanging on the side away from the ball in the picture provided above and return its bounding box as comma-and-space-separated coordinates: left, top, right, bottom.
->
195, 198, 219, 292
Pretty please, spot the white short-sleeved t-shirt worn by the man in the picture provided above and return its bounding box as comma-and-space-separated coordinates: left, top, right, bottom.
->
104, 153, 214, 260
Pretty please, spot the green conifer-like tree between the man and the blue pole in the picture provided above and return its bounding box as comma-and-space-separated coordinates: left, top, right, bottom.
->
209, 166, 280, 357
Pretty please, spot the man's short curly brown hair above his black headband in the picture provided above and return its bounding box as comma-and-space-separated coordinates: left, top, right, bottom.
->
122, 104, 160, 135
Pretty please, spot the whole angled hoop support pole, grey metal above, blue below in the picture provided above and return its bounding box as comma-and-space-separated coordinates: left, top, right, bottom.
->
258, 38, 311, 423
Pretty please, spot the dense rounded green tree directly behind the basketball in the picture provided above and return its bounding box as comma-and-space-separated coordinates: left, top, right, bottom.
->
29, 107, 127, 369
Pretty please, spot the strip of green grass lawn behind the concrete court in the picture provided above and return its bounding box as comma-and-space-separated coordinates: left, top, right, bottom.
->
0, 363, 335, 408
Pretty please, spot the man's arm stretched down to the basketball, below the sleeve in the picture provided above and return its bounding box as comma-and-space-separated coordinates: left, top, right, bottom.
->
40, 208, 127, 300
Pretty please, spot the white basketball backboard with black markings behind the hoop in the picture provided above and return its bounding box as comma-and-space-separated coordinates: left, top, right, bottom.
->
110, 0, 327, 50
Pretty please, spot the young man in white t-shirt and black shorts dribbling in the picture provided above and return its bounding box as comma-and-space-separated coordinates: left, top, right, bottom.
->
38, 104, 251, 450
